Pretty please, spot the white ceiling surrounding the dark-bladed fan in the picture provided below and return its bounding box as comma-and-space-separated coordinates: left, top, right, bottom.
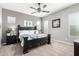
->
0, 3, 73, 17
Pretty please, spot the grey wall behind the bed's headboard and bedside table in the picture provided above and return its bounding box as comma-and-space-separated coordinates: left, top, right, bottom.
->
2, 9, 40, 43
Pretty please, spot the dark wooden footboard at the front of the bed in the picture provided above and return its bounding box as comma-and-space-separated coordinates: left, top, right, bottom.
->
23, 34, 51, 54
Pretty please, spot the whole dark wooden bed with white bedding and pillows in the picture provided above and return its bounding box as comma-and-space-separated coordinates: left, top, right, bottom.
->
17, 25, 51, 54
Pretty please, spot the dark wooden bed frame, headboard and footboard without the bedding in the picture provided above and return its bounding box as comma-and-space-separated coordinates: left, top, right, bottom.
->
17, 25, 51, 54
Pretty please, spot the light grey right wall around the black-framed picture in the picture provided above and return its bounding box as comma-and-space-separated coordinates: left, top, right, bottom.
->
43, 4, 79, 42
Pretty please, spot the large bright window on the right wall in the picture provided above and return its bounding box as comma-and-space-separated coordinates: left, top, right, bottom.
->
69, 13, 79, 36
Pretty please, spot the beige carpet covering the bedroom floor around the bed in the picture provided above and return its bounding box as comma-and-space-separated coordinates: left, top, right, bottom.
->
0, 42, 74, 56
